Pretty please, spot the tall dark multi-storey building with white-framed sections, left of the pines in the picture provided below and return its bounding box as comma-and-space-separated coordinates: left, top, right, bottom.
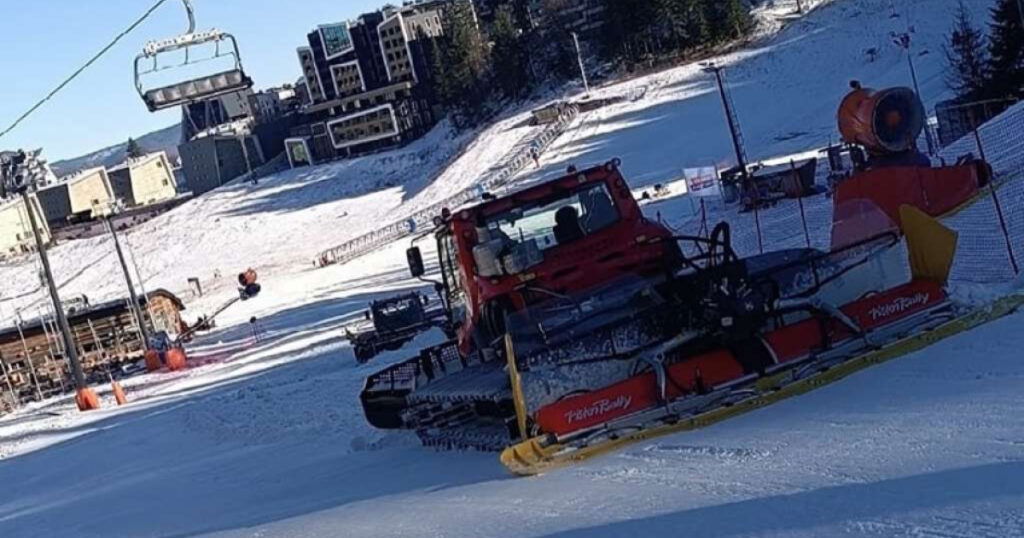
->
292, 0, 450, 161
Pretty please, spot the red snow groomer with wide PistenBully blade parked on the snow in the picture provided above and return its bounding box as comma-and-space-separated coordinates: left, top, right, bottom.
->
360, 152, 978, 474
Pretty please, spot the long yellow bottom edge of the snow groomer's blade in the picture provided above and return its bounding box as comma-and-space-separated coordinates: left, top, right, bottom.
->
501, 294, 1024, 477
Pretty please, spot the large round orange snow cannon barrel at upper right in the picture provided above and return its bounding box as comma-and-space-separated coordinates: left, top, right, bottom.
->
839, 83, 926, 155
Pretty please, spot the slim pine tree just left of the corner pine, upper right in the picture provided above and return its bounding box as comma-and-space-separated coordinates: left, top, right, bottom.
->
943, 0, 988, 100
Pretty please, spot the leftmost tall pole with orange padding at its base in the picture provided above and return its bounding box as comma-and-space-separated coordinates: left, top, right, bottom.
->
0, 151, 99, 411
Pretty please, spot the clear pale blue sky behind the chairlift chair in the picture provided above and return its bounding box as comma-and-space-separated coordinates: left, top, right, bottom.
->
0, 0, 384, 161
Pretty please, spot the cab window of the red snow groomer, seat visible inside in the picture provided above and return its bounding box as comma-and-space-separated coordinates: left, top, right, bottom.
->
486, 183, 618, 250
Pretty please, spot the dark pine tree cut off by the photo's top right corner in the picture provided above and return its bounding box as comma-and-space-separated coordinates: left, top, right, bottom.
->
987, 0, 1024, 98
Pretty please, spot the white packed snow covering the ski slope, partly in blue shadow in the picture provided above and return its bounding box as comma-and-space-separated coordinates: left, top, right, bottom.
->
0, 0, 1024, 537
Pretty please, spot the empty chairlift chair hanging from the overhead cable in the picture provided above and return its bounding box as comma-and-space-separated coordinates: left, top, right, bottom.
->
135, 0, 253, 112
